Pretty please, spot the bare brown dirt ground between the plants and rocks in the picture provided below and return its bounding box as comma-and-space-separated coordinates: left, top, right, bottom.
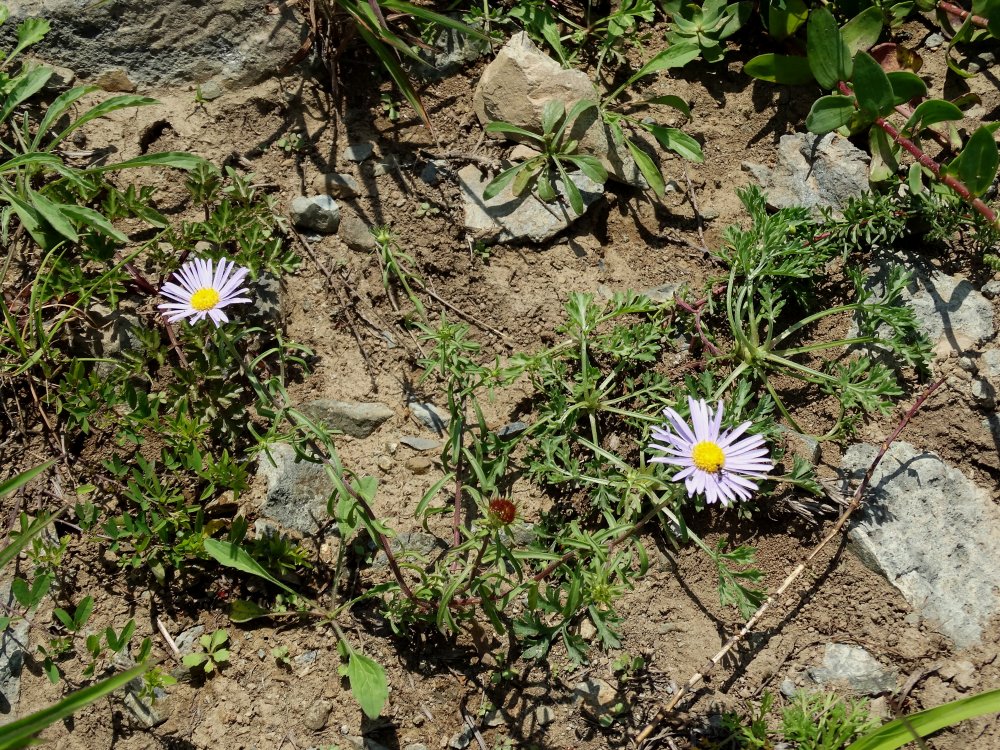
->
7, 14, 1000, 750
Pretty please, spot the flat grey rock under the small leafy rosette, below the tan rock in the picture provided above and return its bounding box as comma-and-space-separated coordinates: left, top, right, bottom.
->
458, 164, 604, 243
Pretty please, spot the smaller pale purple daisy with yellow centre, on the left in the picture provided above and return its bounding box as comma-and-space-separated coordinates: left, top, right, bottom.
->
158, 258, 252, 328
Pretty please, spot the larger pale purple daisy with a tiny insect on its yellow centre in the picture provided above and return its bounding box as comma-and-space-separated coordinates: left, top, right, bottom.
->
649, 397, 774, 507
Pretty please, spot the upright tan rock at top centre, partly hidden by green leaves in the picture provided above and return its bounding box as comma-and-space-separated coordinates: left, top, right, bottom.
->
472, 32, 646, 188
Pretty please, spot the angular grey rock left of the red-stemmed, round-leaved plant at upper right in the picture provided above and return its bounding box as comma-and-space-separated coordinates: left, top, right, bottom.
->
743, 133, 870, 216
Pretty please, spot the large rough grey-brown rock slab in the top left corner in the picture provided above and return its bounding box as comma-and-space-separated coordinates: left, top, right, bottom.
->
0, 0, 309, 90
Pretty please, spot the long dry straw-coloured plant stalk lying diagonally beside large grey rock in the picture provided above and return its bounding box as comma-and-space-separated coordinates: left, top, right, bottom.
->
635, 379, 944, 746
